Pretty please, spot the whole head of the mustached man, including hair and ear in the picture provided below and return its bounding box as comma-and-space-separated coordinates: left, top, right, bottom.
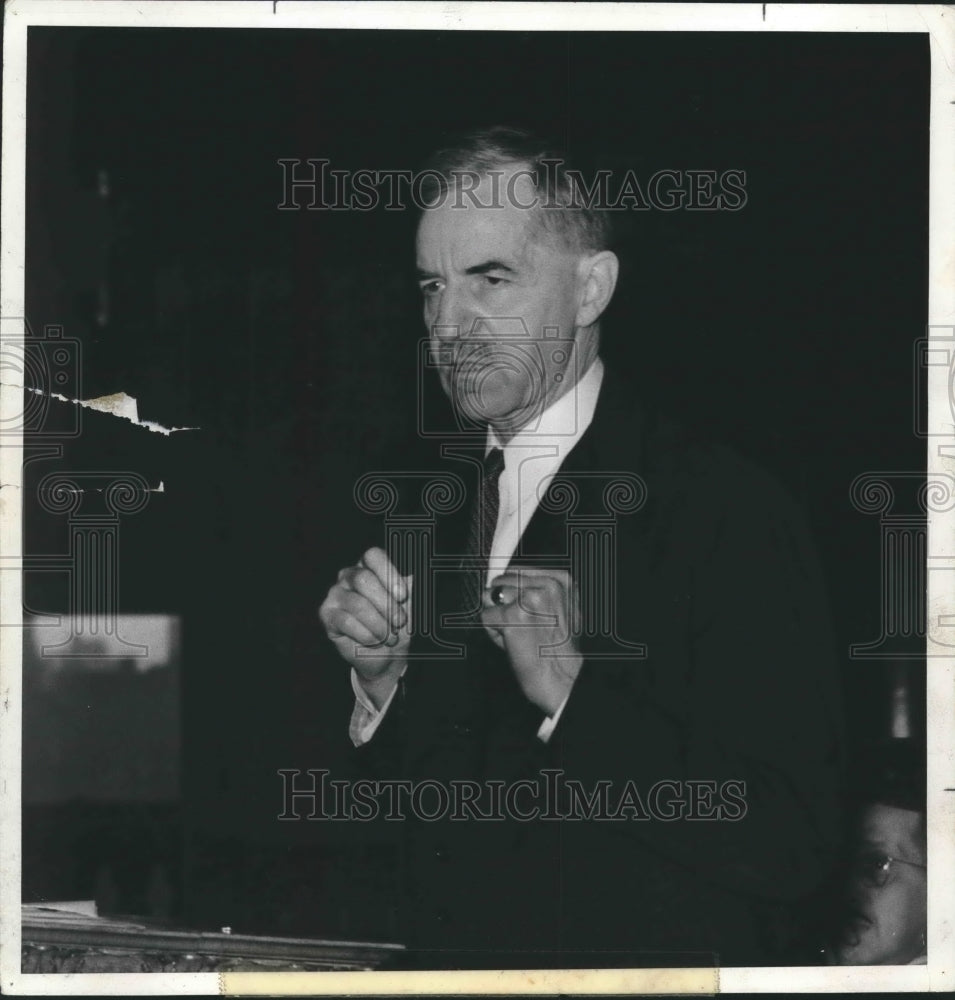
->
417, 127, 619, 440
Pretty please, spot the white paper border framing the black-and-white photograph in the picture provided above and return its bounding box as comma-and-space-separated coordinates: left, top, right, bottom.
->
0, 0, 955, 995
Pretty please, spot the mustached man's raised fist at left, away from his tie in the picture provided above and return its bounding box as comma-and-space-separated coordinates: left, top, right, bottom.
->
318, 548, 412, 708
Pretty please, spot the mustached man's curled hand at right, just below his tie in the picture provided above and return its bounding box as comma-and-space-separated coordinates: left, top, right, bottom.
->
481, 566, 584, 715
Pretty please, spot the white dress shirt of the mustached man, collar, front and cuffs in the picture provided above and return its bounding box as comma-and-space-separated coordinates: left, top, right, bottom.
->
348, 358, 604, 746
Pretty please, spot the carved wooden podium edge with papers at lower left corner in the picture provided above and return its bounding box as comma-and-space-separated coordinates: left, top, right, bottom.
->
21, 904, 404, 973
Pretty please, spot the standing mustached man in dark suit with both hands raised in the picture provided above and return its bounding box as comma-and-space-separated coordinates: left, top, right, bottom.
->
320, 129, 839, 968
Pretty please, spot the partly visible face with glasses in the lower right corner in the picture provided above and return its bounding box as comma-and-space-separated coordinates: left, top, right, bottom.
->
836, 804, 926, 965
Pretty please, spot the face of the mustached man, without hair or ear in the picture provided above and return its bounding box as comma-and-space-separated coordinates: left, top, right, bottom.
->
417, 168, 595, 432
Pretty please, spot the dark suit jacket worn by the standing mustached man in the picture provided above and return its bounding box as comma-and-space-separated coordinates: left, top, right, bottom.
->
357, 373, 841, 968
